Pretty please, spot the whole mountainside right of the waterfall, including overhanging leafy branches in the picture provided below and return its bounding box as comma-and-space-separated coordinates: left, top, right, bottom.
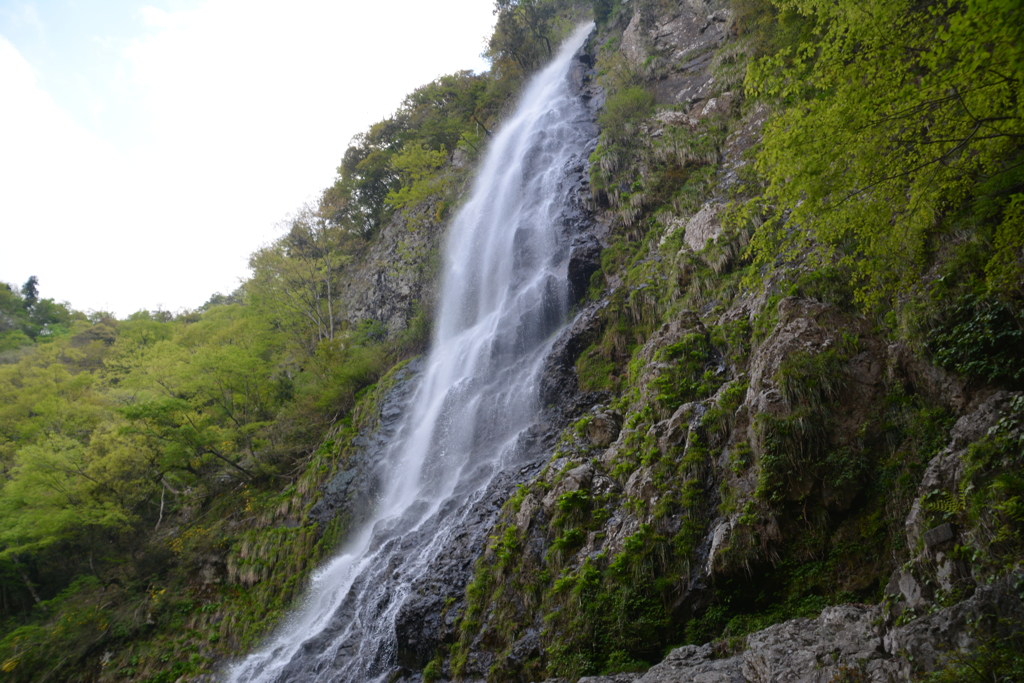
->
430, 0, 1024, 681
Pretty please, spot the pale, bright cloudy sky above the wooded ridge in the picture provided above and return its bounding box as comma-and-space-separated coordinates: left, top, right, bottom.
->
0, 0, 495, 317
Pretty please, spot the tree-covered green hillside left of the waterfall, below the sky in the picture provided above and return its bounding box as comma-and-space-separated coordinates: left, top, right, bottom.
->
0, 57, 522, 681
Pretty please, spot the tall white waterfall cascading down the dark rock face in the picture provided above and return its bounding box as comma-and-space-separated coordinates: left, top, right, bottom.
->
228, 26, 592, 683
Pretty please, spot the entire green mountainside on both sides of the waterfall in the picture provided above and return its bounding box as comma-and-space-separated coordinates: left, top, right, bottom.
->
0, 0, 1024, 683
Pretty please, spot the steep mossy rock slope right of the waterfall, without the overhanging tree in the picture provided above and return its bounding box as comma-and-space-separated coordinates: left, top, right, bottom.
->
329, 2, 1024, 681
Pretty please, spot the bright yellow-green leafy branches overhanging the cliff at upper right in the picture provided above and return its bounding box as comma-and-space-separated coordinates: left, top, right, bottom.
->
746, 0, 1024, 303
